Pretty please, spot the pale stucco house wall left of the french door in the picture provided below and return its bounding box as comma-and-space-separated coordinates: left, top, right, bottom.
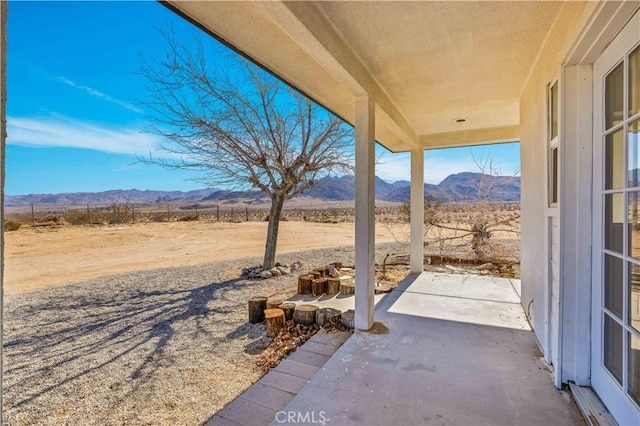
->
520, 2, 595, 352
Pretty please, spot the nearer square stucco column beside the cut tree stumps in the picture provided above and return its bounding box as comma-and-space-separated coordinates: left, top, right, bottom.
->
355, 96, 375, 330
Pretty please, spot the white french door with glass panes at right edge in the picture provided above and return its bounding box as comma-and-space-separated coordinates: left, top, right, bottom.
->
591, 12, 640, 425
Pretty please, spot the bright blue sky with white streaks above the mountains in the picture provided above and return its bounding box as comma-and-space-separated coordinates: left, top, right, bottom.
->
5, 1, 520, 195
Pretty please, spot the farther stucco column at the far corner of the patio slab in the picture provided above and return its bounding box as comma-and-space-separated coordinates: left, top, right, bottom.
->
410, 149, 424, 273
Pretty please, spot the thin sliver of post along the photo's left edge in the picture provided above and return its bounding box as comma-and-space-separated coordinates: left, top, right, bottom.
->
0, 1, 8, 412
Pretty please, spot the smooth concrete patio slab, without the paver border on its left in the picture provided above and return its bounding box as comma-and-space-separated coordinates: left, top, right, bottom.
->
271, 274, 580, 425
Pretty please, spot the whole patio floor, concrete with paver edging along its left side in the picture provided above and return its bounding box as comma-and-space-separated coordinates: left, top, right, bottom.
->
208, 273, 581, 425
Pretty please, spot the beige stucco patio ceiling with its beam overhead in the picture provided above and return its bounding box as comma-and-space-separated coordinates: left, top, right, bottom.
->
168, 1, 564, 151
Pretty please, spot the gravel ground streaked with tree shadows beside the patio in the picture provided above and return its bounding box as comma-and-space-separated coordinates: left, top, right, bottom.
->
3, 244, 407, 425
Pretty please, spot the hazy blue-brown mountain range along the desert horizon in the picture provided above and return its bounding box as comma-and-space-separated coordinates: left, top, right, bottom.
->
5, 172, 520, 207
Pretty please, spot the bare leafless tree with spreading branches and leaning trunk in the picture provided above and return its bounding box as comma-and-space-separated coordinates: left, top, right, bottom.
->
140, 31, 353, 269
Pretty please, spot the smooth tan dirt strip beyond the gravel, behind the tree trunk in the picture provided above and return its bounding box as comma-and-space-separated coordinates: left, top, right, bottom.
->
4, 222, 405, 294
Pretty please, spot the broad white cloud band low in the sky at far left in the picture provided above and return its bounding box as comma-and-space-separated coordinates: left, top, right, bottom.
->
7, 116, 160, 154
